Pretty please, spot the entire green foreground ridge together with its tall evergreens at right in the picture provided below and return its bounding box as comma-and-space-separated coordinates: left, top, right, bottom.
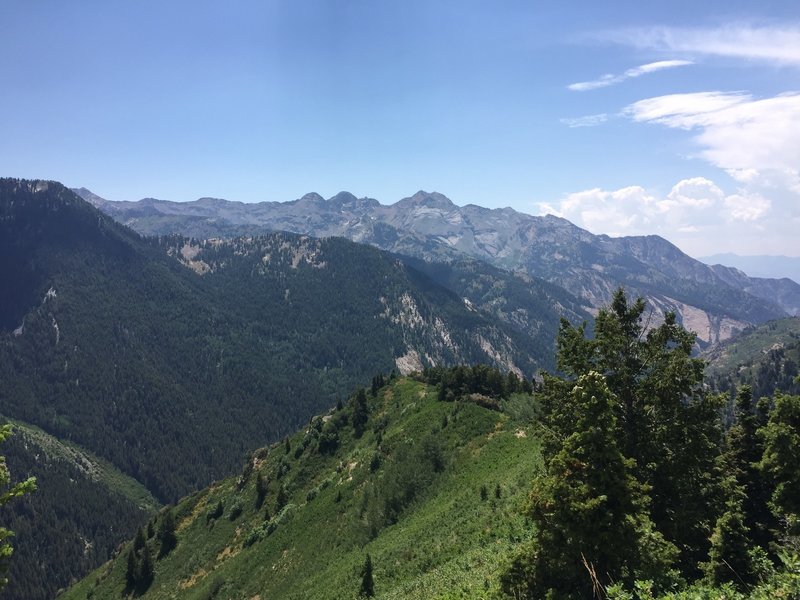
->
54, 290, 800, 600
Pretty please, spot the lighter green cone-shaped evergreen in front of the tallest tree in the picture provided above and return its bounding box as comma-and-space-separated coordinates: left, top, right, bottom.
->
503, 372, 677, 598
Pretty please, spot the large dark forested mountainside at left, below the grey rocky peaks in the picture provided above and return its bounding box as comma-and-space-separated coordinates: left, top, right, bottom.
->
0, 180, 556, 500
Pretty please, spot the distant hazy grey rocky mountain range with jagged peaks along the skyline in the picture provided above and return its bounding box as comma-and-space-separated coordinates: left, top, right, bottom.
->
73, 190, 800, 344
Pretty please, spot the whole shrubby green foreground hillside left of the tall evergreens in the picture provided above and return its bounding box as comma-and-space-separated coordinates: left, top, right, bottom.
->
62, 367, 540, 600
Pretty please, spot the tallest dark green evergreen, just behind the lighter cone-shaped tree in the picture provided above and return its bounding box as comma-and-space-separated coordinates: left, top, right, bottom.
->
552, 290, 724, 576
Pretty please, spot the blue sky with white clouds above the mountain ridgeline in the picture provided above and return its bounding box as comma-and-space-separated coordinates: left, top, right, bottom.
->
0, 0, 800, 256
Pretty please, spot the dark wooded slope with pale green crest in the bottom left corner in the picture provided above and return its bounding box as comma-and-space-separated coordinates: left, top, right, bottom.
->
2, 422, 159, 600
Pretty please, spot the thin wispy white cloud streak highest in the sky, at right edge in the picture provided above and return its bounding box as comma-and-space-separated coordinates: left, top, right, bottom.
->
599, 23, 800, 66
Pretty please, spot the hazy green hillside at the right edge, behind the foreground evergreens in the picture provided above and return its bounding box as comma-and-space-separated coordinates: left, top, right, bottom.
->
704, 317, 800, 398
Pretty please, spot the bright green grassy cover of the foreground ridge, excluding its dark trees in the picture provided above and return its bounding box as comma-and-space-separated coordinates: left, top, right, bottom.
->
62, 379, 540, 600
